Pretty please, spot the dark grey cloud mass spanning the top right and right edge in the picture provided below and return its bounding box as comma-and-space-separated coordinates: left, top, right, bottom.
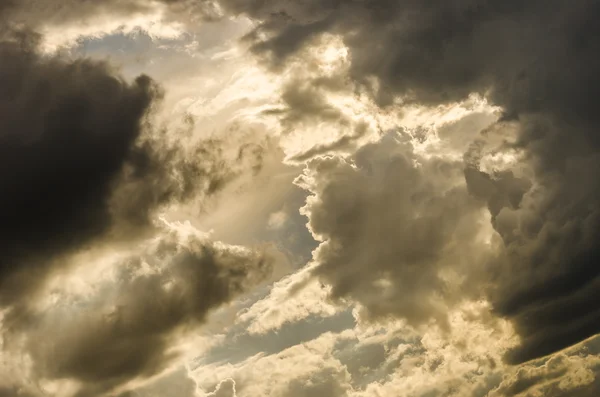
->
212, 0, 600, 362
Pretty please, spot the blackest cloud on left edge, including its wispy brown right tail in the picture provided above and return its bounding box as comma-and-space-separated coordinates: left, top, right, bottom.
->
0, 27, 241, 312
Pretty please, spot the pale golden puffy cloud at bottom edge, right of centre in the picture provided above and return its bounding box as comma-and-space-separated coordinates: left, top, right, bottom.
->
344, 302, 514, 397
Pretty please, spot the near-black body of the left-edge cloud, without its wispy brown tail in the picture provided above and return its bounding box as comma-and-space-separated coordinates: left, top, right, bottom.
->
0, 27, 158, 304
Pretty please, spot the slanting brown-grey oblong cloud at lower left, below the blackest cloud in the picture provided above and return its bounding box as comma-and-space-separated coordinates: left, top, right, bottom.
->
26, 234, 273, 396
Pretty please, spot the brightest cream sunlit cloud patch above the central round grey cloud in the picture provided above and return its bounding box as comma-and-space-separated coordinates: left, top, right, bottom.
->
270, 34, 497, 163
